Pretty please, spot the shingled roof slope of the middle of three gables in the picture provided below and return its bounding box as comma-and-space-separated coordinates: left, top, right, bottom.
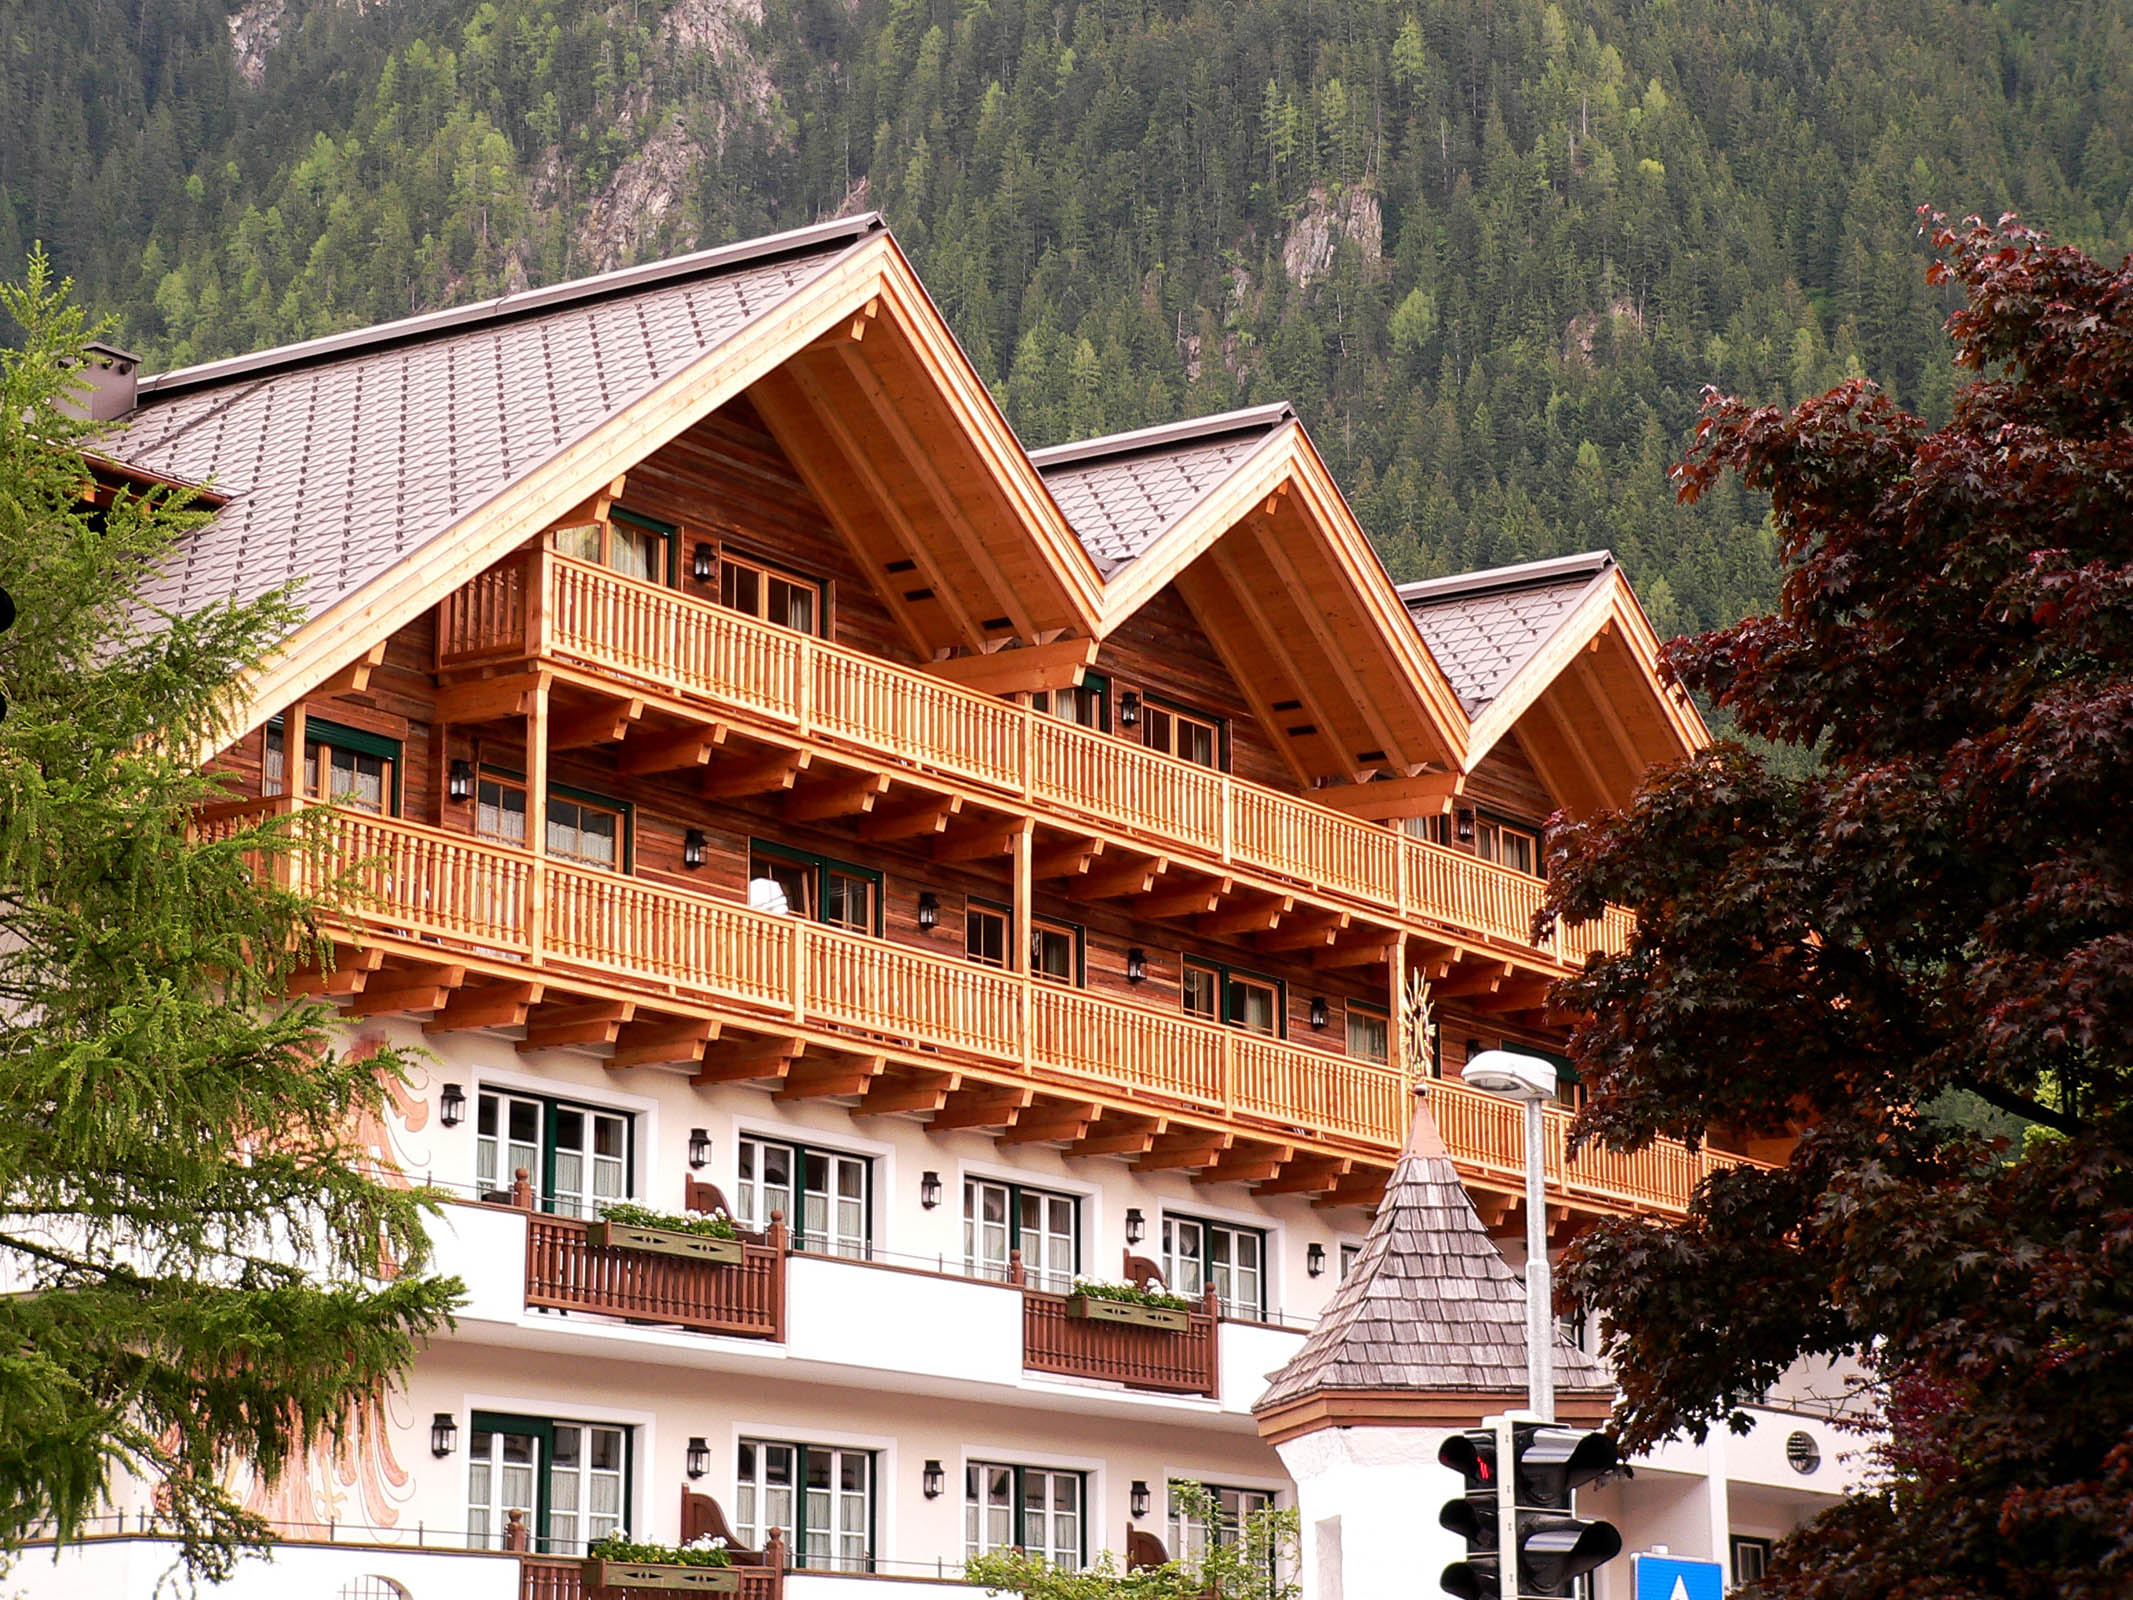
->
1030, 403, 1295, 578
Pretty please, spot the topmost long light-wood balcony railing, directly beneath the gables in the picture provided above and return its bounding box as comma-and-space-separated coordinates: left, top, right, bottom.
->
437, 550, 1630, 969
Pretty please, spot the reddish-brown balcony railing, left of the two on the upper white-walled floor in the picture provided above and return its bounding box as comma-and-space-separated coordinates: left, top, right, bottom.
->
527, 1216, 785, 1340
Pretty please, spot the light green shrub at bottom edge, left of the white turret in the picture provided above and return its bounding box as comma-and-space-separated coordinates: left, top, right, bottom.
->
962, 1483, 1301, 1600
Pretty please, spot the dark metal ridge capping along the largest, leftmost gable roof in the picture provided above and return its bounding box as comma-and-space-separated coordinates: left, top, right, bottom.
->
139, 211, 887, 405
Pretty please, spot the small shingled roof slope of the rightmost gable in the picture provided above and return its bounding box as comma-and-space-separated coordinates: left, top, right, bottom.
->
1399, 550, 1615, 717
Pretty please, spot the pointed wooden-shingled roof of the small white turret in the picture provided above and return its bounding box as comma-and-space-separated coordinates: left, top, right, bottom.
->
1252, 1092, 1615, 1434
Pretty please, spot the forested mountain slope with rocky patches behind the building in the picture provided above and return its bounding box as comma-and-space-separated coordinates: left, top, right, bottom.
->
0, 0, 2133, 631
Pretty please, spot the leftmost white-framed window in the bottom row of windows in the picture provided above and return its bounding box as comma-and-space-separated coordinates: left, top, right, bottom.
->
467, 1410, 629, 1555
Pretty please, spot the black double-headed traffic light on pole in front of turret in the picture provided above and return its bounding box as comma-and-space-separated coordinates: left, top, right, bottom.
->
1438, 1412, 1621, 1600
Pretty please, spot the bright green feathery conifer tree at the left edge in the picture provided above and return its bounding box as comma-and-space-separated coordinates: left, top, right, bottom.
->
0, 256, 456, 1579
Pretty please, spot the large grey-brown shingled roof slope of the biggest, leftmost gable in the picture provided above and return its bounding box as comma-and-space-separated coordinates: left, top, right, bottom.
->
98, 215, 881, 614
